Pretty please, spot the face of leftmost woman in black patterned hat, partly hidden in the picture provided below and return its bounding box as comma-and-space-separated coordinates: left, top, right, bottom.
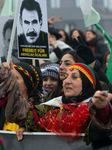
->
15, 70, 28, 99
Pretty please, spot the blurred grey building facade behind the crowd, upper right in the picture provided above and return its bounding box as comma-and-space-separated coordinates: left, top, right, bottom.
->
47, 0, 112, 37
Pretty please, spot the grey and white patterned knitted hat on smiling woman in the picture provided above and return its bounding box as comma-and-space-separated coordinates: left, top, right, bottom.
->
41, 64, 59, 79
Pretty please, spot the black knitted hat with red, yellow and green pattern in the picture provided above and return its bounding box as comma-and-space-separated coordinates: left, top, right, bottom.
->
14, 62, 42, 92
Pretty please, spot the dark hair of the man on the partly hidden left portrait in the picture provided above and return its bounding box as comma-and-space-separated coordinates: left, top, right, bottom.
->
2, 19, 13, 38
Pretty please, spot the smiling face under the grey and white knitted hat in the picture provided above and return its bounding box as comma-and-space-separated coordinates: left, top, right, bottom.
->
43, 76, 58, 90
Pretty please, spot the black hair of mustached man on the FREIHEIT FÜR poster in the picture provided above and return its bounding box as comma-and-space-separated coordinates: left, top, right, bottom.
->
20, 0, 42, 21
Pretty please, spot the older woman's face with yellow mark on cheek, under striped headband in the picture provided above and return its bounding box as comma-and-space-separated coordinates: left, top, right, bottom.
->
63, 69, 82, 97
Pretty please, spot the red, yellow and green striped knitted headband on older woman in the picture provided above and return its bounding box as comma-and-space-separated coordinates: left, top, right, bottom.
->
67, 63, 96, 89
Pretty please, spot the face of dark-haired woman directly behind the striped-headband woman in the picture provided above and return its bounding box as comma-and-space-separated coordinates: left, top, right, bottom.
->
59, 54, 75, 80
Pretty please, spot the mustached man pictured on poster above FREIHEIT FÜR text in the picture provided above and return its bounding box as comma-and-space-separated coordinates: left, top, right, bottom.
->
19, 0, 48, 45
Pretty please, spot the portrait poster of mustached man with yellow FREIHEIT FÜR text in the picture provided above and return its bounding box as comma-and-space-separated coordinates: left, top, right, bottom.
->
17, 0, 49, 59
